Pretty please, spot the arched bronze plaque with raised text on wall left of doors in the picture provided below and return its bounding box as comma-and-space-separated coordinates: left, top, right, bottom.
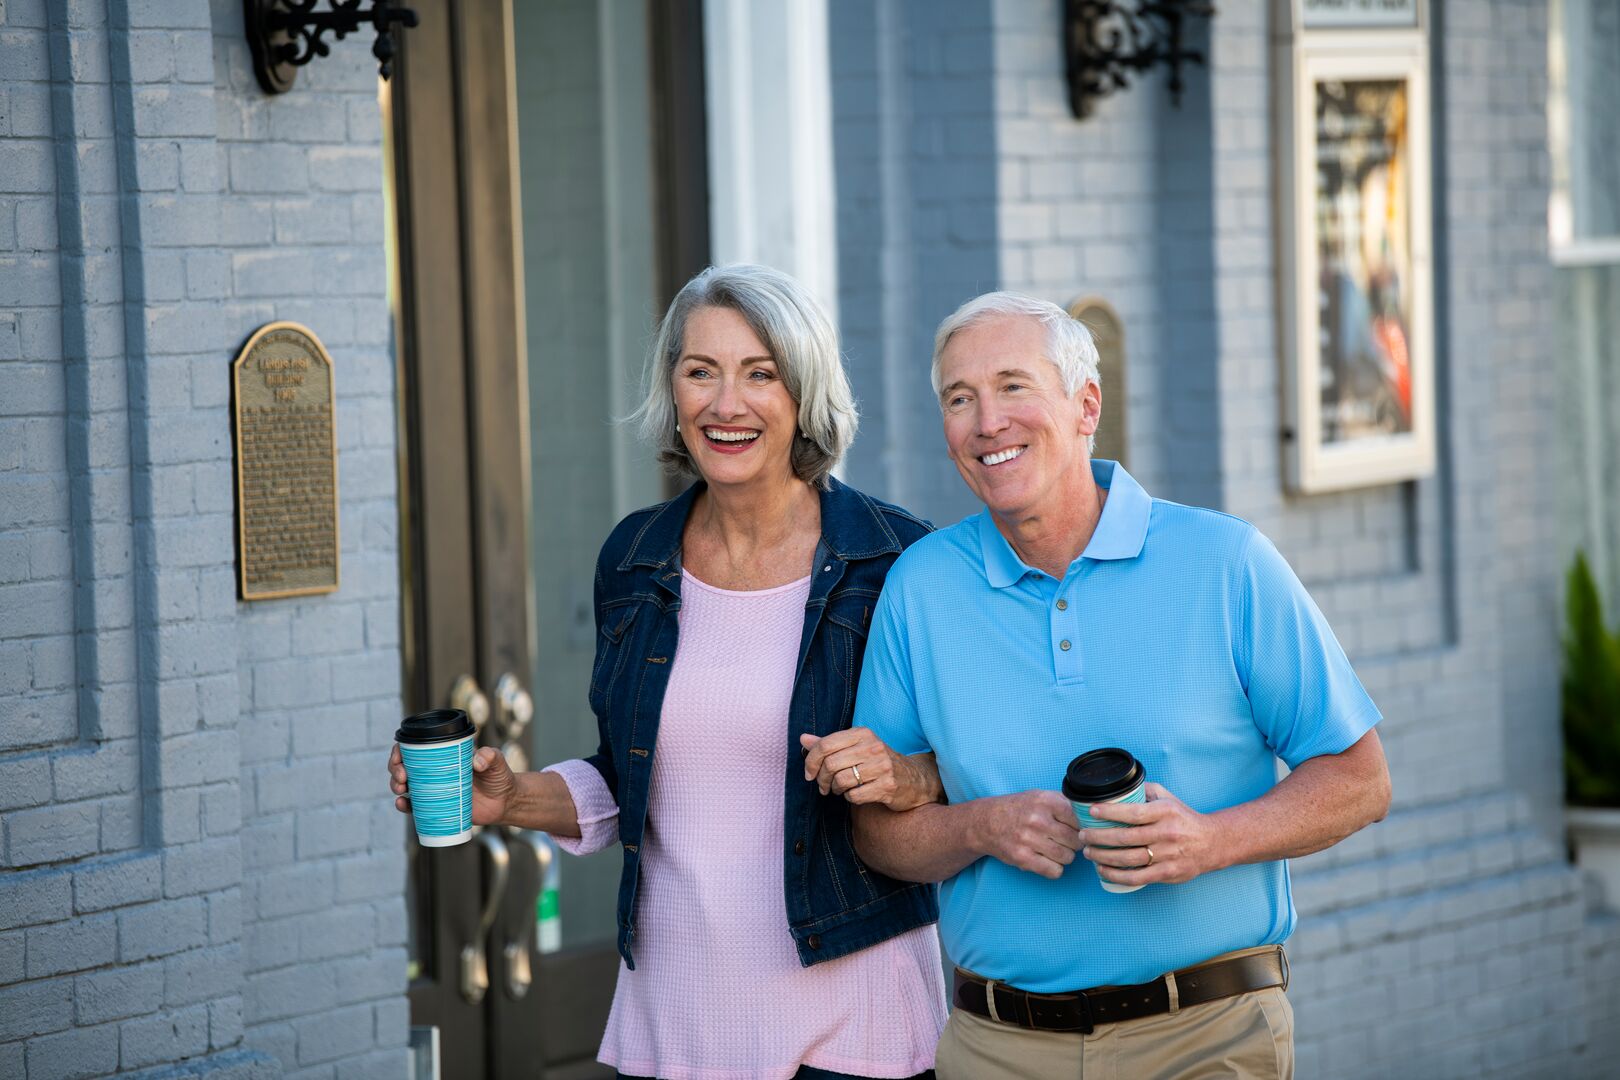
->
232, 322, 337, 601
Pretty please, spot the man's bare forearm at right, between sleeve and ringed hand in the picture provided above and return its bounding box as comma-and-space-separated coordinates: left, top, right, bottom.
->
1213, 730, 1390, 866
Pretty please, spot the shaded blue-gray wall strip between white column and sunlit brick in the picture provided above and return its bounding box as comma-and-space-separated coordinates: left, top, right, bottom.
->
828, 0, 998, 525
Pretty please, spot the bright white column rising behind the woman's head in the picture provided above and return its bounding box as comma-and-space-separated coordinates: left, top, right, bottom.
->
703, 0, 838, 322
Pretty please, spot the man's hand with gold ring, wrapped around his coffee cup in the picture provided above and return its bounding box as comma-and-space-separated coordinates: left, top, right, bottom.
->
1081, 784, 1230, 886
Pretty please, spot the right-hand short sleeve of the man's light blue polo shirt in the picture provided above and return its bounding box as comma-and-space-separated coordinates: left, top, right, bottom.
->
1234, 533, 1382, 767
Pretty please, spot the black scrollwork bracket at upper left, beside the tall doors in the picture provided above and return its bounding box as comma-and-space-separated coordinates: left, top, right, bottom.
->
241, 0, 416, 94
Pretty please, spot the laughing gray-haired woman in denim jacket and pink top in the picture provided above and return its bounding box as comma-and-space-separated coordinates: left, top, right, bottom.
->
389, 266, 944, 1080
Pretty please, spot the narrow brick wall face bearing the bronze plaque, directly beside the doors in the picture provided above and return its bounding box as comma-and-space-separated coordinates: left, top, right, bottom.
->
212, 0, 405, 1080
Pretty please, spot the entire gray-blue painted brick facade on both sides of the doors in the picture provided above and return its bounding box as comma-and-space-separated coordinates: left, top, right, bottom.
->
0, 0, 1620, 1080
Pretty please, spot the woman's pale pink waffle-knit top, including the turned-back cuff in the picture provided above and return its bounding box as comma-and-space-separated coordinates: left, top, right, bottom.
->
552, 573, 944, 1080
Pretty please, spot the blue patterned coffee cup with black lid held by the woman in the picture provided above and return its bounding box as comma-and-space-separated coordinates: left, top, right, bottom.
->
394, 709, 478, 847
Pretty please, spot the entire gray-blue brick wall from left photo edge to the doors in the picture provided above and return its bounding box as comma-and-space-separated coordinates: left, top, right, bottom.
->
0, 0, 407, 1080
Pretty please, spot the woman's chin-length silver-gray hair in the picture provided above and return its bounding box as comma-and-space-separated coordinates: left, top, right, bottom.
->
630, 262, 860, 487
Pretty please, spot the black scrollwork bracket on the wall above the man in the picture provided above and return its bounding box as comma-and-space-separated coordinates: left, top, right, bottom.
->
1063, 0, 1215, 120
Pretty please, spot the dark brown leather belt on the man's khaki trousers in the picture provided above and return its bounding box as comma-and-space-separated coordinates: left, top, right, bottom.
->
951, 946, 1288, 1035
